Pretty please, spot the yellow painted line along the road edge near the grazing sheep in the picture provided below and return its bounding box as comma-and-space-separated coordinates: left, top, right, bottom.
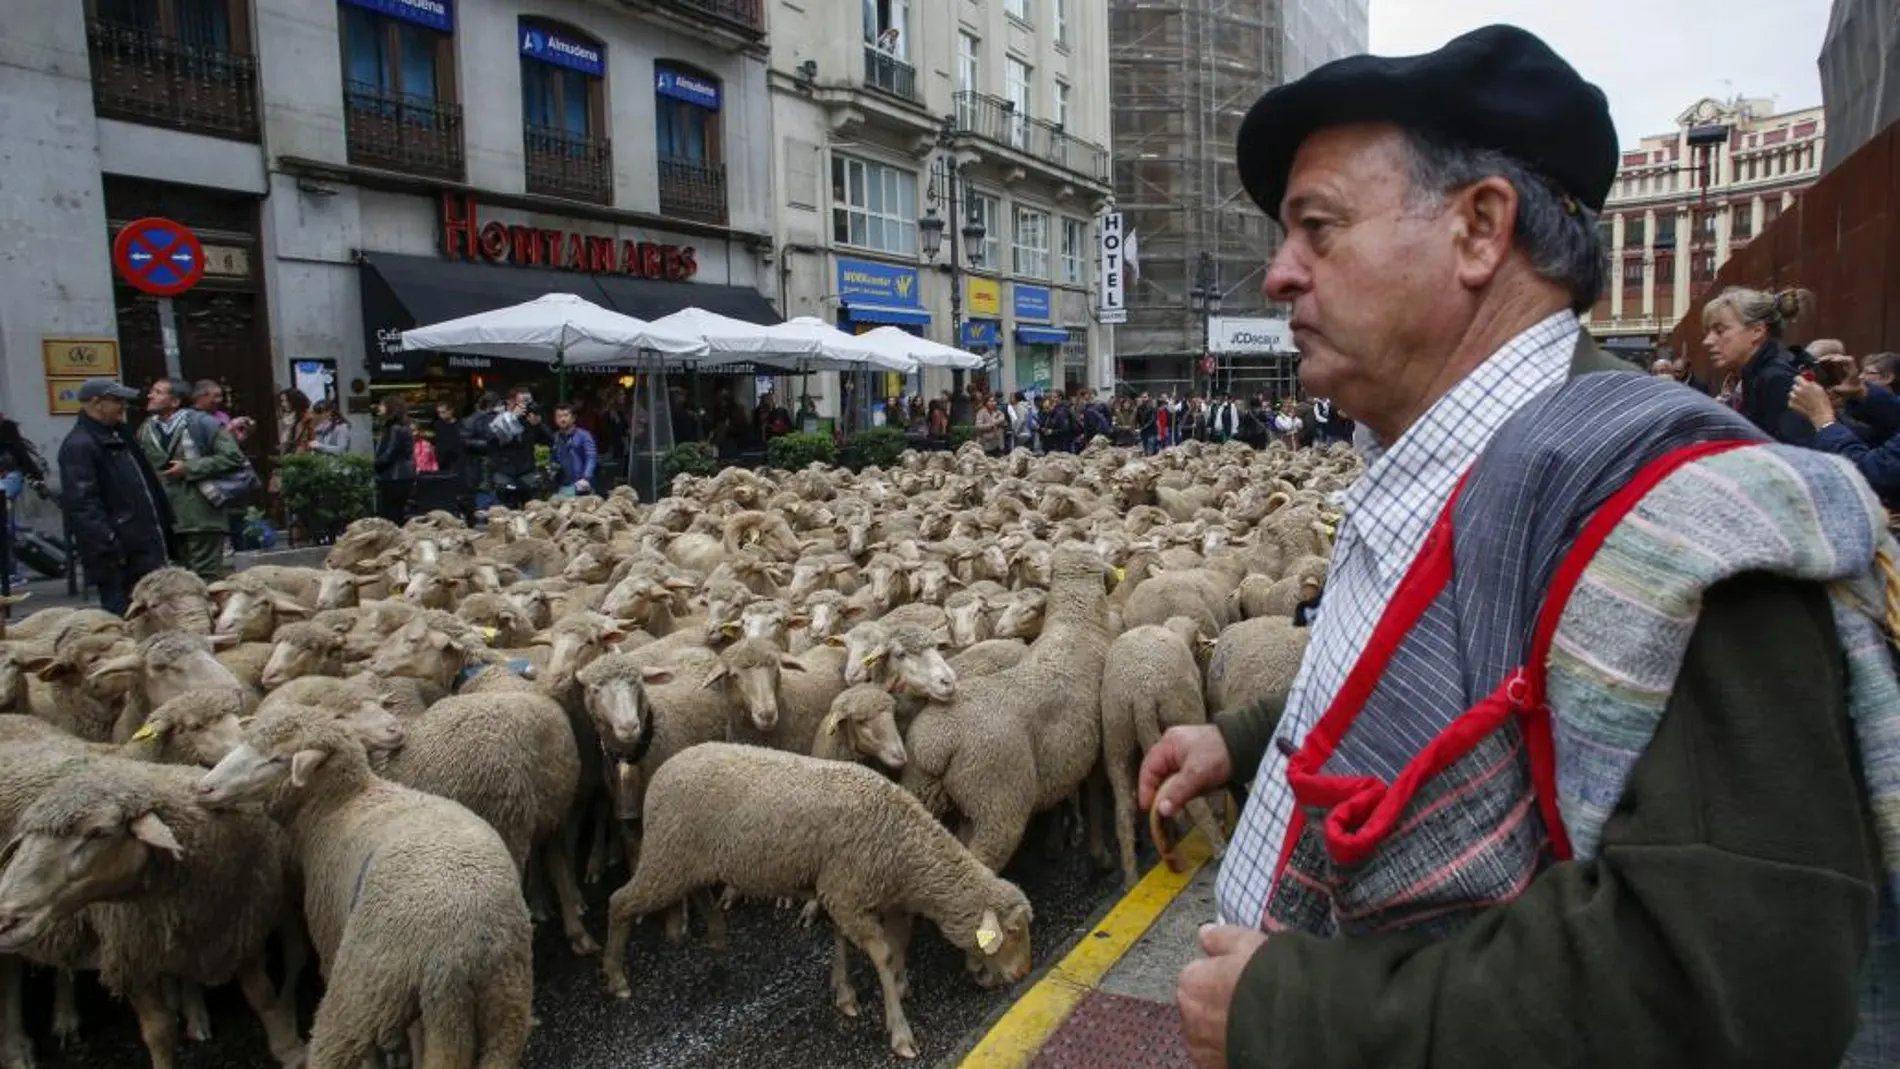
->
958, 830, 1212, 1069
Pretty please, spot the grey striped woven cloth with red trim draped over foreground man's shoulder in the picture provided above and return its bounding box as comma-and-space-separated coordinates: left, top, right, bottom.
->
1248, 374, 1900, 1069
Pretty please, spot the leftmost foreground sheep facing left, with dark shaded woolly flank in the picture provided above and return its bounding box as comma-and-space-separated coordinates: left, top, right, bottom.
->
0, 758, 304, 1067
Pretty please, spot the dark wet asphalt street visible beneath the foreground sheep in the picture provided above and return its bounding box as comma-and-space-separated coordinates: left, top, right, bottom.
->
14, 828, 1121, 1069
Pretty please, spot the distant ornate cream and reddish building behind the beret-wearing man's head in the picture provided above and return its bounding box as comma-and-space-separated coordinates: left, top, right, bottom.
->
1587, 99, 1826, 359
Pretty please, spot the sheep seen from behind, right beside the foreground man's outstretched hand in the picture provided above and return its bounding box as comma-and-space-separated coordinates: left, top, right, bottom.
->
1102, 617, 1224, 889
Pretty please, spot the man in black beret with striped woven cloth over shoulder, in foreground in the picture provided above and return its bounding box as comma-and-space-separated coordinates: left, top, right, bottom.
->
1140, 27, 1900, 1069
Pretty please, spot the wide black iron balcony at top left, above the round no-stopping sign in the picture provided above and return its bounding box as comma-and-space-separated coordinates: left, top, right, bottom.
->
86, 19, 258, 141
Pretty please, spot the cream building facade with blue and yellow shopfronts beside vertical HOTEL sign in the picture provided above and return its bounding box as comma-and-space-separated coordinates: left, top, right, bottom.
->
770, 0, 1110, 425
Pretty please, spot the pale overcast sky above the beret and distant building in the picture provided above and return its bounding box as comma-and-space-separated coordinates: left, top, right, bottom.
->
1372, 0, 1832, 146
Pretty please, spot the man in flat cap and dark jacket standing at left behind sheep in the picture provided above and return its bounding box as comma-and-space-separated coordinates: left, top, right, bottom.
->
59, 378, 171, 615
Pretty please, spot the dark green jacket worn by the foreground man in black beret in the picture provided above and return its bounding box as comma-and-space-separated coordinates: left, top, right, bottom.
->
1216, 575, 1879, 1069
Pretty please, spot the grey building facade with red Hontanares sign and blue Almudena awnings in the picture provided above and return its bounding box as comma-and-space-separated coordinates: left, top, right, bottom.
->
0, 0, 775, 480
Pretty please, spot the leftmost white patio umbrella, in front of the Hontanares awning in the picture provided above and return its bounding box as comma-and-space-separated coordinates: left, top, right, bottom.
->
403, 292, 707, 366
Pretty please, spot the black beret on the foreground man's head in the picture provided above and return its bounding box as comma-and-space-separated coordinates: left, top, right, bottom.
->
1235, 27, 1617, 220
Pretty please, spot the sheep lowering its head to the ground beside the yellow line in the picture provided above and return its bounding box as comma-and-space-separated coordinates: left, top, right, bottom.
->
602, 742, 1034, 1058
